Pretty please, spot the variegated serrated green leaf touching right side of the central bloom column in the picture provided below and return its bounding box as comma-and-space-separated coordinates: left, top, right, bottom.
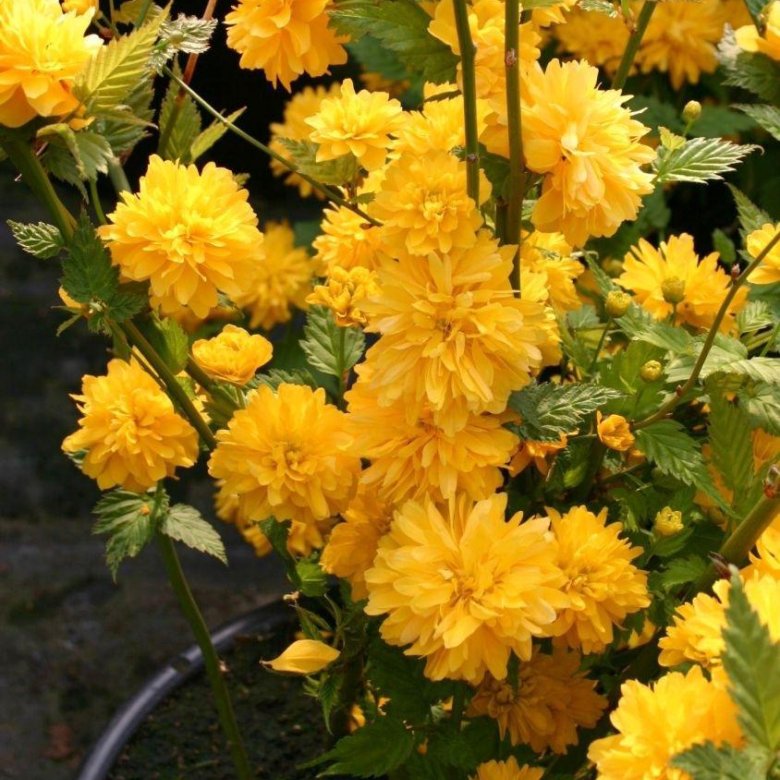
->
509, 382, 621, 441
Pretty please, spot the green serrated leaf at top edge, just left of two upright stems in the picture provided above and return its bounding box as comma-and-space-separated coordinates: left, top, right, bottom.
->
329, 0, 458, 84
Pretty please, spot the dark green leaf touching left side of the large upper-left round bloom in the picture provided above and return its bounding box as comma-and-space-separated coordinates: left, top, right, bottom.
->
62, 214, 119, 310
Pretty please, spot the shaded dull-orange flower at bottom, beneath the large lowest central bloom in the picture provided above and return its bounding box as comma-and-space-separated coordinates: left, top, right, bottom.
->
468, 647, 607, 753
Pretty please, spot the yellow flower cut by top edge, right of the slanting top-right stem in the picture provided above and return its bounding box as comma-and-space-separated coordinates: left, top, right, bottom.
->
636, 0, 726, 90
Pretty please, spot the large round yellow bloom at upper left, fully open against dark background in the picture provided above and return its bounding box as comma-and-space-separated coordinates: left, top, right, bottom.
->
98, 155, 263, 318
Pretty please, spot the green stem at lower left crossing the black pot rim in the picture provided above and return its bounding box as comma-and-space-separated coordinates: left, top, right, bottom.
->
152, 532, 254, 780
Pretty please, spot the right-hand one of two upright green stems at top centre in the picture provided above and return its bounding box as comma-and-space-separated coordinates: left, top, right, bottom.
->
504, 0, 524, 297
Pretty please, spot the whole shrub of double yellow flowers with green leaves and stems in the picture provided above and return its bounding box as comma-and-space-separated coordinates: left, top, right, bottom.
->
0, 0, 780, 780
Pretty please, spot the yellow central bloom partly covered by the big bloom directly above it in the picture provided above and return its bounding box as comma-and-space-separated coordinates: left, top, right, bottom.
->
346, 364, 517, 504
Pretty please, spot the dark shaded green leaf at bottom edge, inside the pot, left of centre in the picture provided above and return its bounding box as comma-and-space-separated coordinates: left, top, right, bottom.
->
307, 717, 415, 777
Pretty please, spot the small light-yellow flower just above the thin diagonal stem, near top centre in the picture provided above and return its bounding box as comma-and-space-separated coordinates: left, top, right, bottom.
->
306, 79, 403, 171
